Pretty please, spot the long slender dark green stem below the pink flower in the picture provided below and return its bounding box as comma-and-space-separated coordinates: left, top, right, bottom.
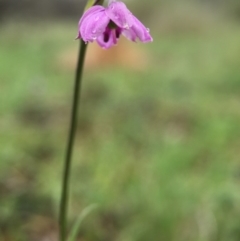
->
59, 40, 87, 241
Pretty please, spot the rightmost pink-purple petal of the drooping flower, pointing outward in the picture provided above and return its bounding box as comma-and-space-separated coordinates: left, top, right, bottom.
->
123, 16, 153, 43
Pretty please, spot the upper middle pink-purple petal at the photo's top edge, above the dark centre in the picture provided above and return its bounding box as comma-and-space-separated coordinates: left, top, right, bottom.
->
106, 1, 133, 29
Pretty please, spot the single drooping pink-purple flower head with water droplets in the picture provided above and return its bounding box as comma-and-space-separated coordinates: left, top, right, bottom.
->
77, 0, 152, 49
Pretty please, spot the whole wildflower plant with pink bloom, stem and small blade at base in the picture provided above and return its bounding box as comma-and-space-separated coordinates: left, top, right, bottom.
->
59, 0, 153, 241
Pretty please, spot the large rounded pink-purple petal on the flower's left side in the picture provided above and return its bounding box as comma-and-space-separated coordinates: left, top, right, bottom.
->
79, 6, 110, 42
